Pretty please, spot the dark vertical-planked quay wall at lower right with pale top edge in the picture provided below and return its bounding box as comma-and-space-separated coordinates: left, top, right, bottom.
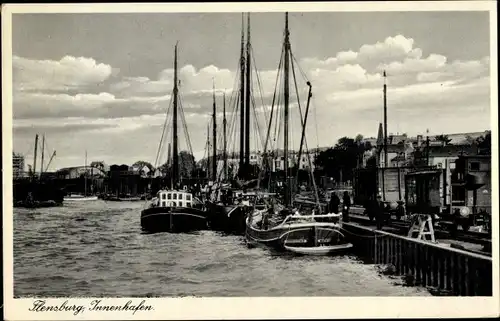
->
343, 223, 493, 296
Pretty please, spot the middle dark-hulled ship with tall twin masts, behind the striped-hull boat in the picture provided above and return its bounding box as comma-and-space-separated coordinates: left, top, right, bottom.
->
208, 13, 264, 235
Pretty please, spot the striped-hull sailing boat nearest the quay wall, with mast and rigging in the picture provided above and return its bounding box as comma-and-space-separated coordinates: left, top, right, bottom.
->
245, 13, 352, 255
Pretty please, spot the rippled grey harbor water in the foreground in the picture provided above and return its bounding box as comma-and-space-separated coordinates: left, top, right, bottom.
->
14, 200, 431, 298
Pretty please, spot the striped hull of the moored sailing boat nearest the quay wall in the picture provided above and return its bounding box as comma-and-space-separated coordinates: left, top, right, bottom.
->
245, 223, 346, 251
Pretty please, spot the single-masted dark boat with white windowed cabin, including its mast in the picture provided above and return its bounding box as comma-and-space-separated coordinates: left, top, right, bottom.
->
141, 44, 208, 233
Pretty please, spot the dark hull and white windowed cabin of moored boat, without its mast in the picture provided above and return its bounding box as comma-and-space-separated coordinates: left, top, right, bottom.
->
141, 190, 208, 233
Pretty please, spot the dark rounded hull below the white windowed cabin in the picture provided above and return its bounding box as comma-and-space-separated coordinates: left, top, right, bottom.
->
141, 207, 208, 233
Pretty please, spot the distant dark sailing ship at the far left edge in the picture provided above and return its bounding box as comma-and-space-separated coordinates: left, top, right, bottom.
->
13, 134, 64, 208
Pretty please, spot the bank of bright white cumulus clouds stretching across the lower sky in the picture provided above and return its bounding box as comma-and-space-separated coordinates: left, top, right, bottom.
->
9, 35, 490, 165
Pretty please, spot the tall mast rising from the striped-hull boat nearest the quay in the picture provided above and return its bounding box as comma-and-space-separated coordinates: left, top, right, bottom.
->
283, 12, 290, 206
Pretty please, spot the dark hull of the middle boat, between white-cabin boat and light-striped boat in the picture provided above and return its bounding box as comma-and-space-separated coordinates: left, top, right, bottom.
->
208, 204, 251, 235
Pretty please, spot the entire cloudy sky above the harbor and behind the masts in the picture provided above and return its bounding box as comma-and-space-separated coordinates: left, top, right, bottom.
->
12, 12, 490, 170
